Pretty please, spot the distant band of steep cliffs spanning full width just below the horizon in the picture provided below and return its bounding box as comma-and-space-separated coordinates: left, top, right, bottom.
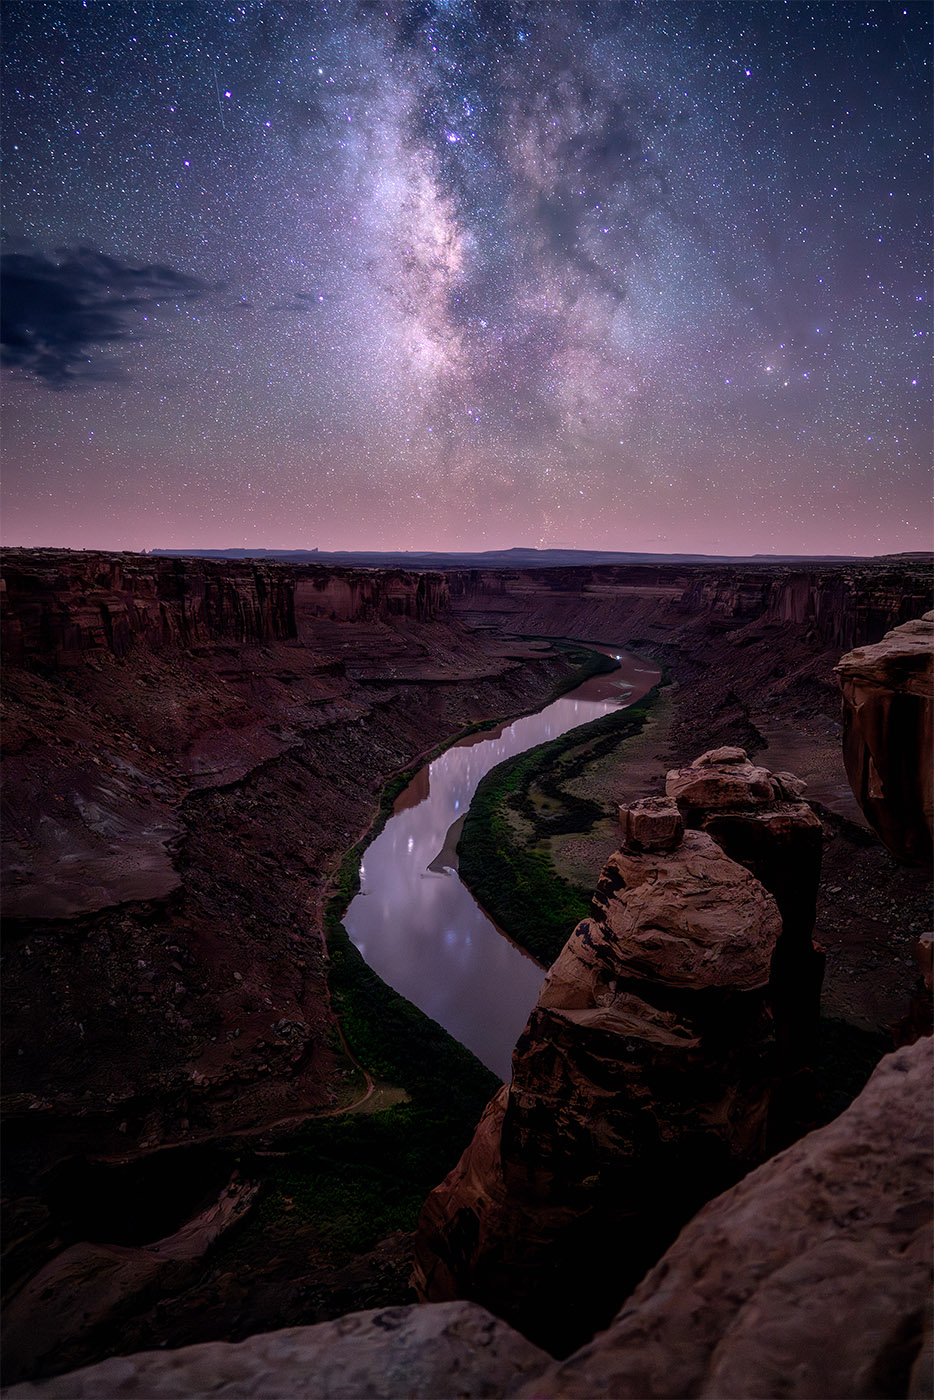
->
7, 550, 931, 686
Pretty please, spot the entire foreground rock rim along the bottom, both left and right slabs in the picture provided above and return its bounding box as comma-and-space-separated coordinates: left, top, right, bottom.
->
4, 1037, 934, 1400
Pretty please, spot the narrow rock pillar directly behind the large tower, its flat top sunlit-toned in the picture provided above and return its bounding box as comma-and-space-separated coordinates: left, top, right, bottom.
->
665, 748, 825, 1148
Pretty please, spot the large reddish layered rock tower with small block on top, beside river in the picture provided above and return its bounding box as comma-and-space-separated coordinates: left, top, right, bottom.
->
414, 805, 781, 1354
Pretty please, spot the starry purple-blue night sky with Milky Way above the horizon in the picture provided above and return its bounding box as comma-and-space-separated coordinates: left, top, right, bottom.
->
1, 0, 933, 554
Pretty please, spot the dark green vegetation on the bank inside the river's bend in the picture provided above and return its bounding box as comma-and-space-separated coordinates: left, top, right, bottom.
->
458, 683, 655, 966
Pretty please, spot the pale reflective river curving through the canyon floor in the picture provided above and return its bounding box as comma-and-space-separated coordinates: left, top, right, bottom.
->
343, 647, 660, 1081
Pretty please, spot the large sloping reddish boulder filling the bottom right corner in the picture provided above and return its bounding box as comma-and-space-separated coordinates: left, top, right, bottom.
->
521, 1037, 934, 1400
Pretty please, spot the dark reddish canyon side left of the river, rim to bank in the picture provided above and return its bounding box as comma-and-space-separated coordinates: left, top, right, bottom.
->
1, 550, 579, 1375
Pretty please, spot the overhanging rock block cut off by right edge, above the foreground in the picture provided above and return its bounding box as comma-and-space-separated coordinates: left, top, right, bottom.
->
836, 612, 934, 867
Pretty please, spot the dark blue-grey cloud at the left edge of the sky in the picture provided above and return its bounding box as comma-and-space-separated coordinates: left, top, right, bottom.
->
0, 248, 210, 389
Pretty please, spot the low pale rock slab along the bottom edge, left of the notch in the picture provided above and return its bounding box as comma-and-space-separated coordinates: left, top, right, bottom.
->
4, 1303, 549, 1400
